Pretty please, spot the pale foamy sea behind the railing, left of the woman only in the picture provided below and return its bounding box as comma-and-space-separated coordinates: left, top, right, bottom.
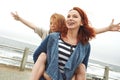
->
0, 36, 37, 68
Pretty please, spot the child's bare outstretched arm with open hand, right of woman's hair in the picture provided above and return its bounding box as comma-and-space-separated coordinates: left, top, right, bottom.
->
95, 19, 120, 34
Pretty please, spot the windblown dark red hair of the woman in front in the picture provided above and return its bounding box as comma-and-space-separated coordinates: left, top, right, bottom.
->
72, 7, 95, 44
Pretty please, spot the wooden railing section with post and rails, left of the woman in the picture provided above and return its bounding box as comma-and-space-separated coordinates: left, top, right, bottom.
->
0, 45, 34, 71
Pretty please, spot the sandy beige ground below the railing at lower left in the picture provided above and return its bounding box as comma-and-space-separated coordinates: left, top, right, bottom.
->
0, 64, 31, 80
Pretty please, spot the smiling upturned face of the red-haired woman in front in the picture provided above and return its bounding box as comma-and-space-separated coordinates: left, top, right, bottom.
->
66, 10, 82, 29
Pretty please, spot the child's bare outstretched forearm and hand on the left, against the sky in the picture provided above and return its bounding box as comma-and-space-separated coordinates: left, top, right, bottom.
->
11, 12, 37, 30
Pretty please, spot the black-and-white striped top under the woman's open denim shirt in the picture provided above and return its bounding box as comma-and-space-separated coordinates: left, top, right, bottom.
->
58, 38, 76, 73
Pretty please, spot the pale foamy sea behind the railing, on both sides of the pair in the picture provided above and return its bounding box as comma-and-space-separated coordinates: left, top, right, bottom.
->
0, 36, 120, 80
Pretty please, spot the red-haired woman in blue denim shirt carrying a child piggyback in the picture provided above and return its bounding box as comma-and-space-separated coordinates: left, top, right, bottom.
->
31, 7, 95, 80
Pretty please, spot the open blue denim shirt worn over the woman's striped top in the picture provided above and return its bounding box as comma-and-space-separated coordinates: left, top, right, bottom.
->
33, 33, 90, 80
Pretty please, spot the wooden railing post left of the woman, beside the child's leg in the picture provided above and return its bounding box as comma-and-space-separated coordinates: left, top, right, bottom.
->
20, 48, 29, 71
